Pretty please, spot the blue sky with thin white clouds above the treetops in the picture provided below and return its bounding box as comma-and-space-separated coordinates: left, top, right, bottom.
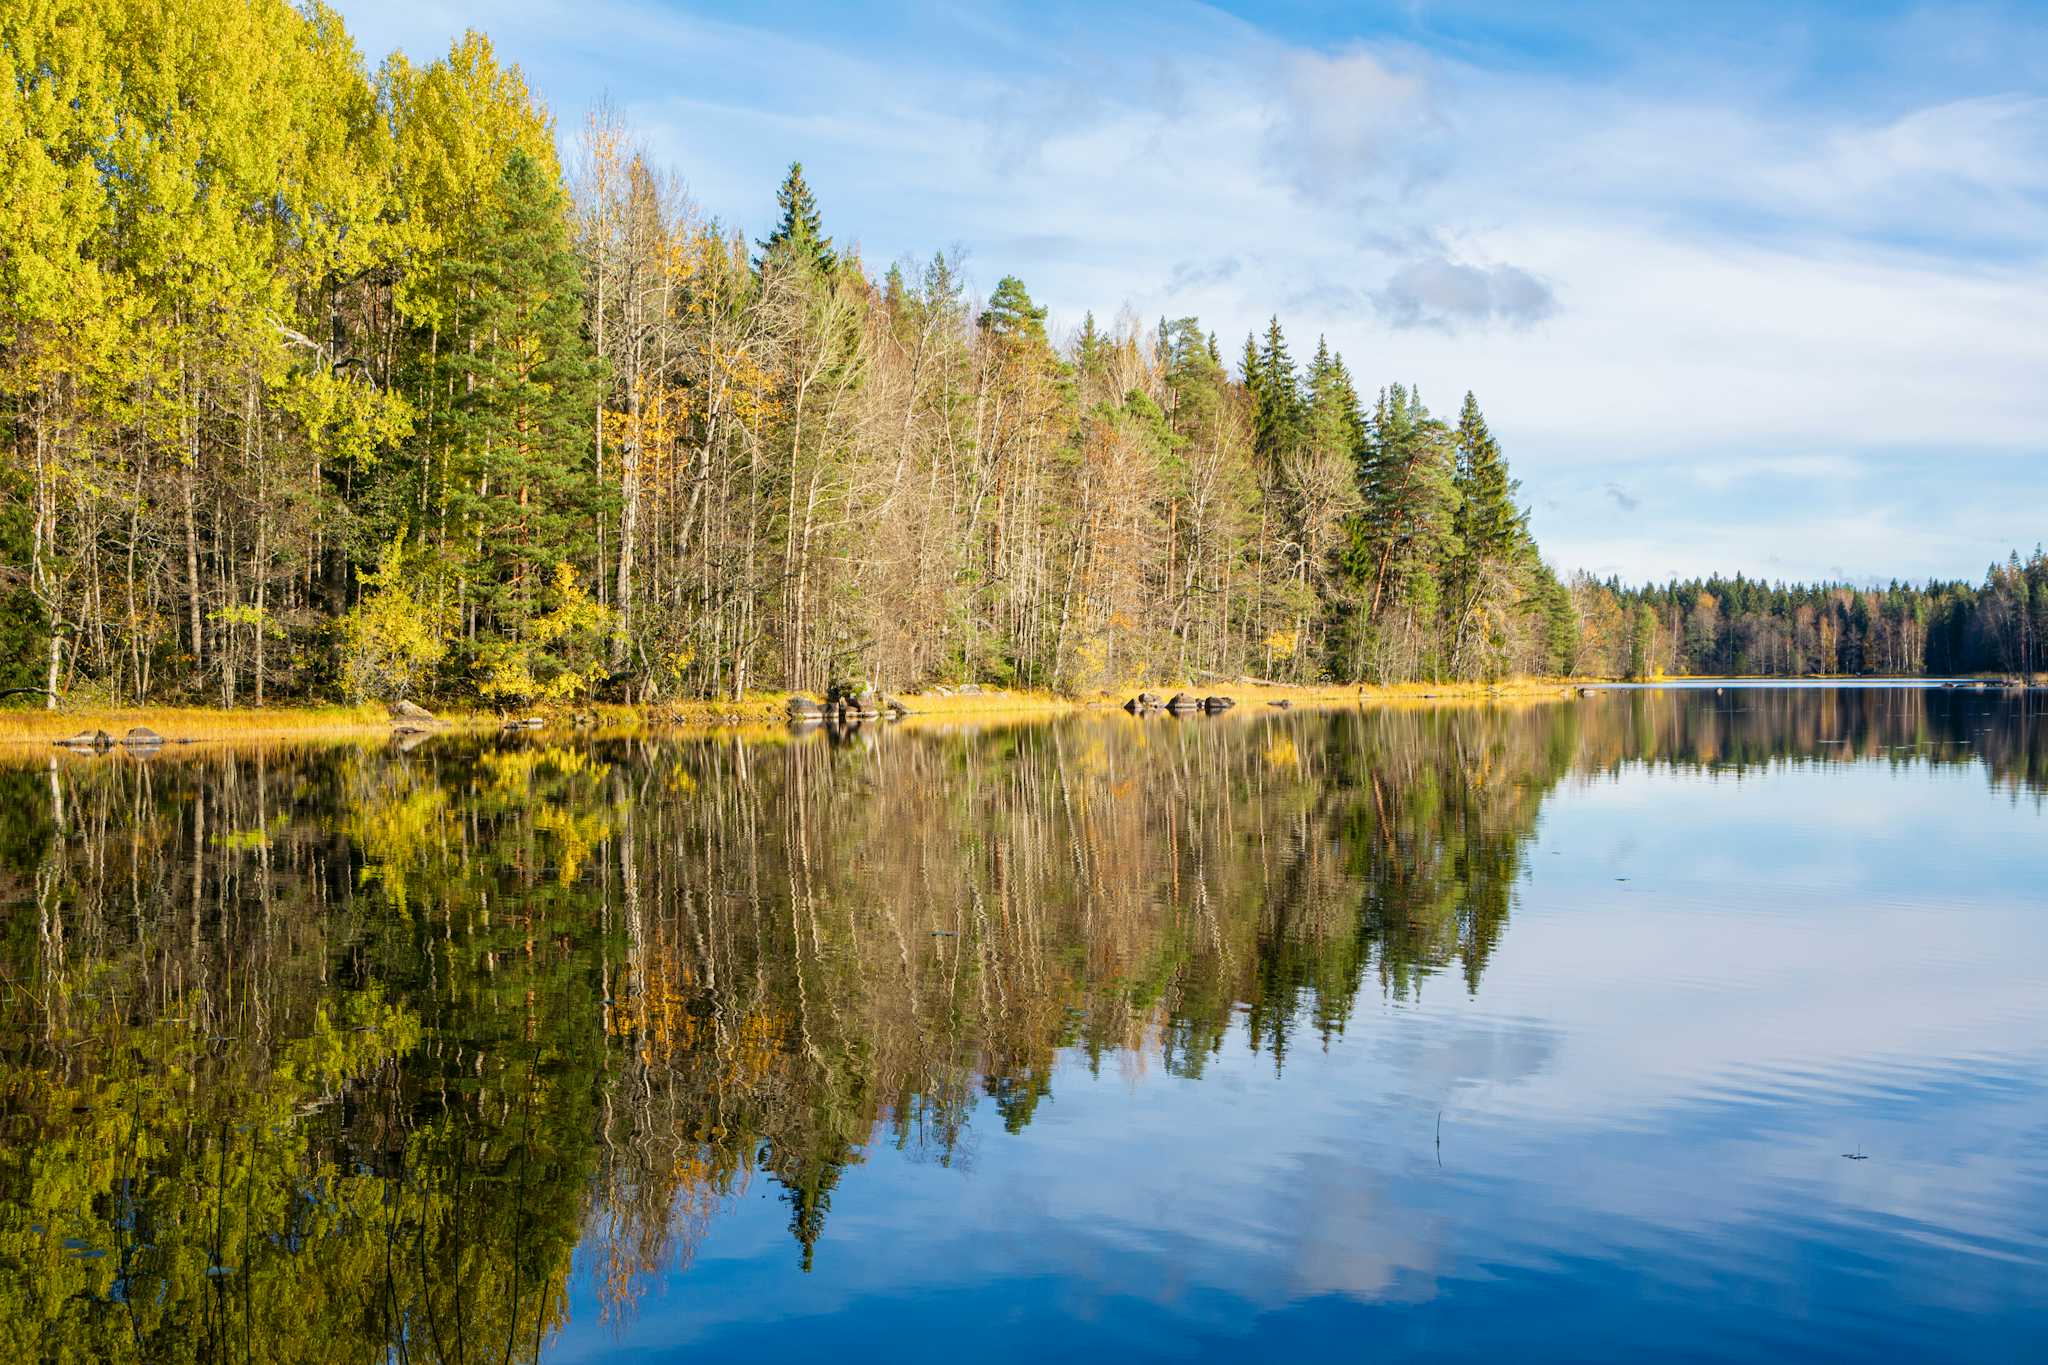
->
338, 0, 2048, 581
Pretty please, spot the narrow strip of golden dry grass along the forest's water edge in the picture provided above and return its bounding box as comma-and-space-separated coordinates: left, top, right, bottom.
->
0, 679, 1575, 745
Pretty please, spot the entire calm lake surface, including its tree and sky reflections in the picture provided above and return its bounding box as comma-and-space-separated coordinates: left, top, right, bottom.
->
0, 688, 2048, 1361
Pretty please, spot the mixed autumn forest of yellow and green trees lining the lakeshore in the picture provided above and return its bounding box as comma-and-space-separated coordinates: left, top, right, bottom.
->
0, 0, 2044, 706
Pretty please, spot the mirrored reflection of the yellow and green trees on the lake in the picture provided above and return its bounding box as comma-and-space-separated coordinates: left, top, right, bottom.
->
0, 690, 2048, 1361
